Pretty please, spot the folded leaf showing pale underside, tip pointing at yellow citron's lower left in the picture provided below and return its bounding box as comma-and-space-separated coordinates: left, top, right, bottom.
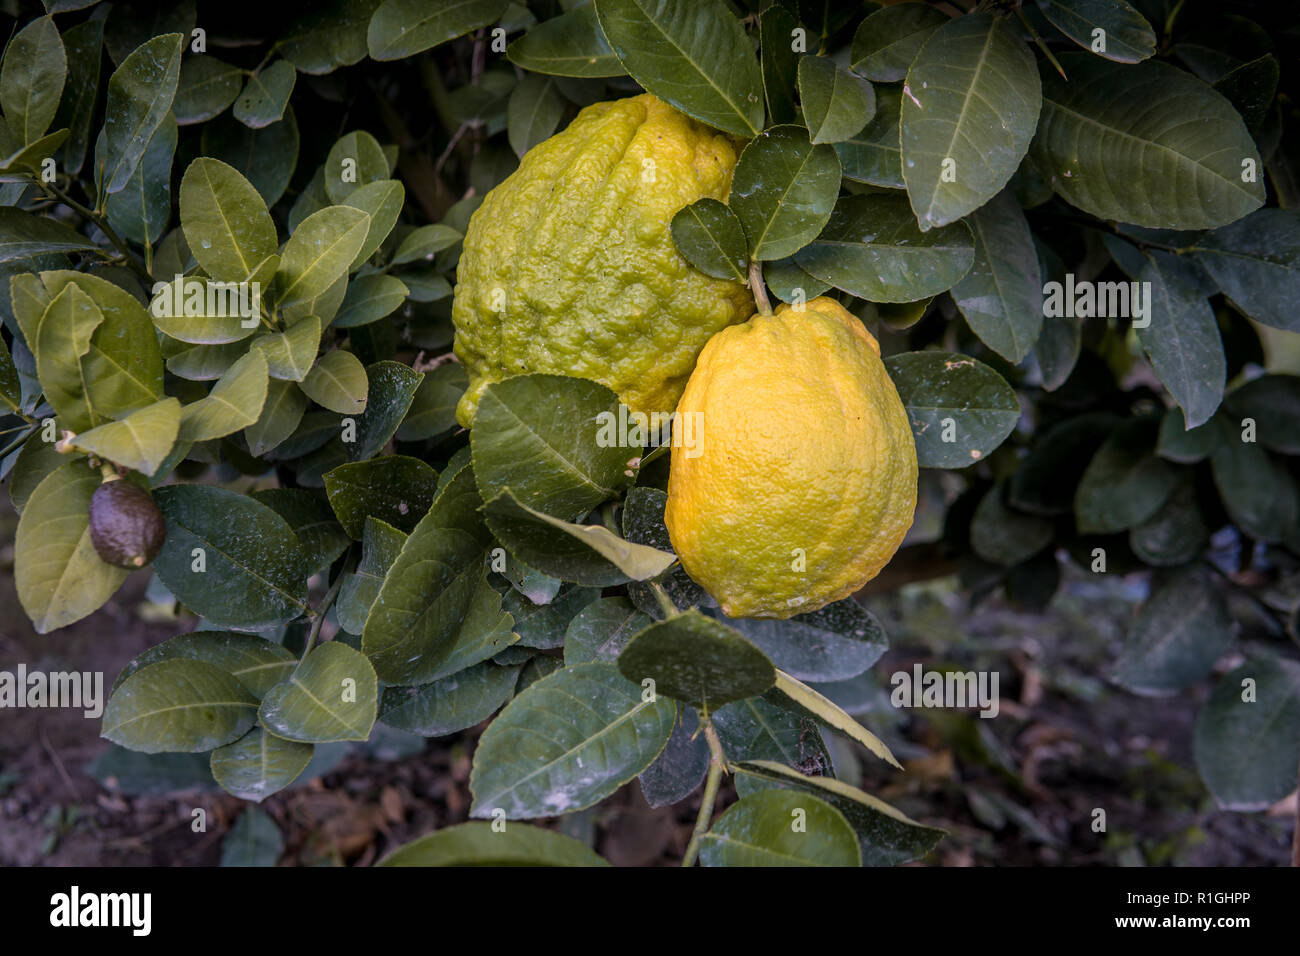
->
484, 488, 677, 587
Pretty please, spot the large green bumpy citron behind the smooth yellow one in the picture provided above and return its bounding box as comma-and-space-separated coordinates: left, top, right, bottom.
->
451, 94, 754, 425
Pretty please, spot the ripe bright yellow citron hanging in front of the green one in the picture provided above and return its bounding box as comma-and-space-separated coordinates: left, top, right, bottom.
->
666, 298, 917, 618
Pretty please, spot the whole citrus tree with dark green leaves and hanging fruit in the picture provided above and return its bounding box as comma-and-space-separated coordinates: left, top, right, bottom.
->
0, 0, 1300, 865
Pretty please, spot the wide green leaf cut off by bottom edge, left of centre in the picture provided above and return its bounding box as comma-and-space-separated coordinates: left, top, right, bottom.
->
377, 823, 608, 866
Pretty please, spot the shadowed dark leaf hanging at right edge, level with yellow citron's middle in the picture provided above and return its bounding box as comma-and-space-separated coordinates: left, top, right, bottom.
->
1210, 427, 1300, 542
